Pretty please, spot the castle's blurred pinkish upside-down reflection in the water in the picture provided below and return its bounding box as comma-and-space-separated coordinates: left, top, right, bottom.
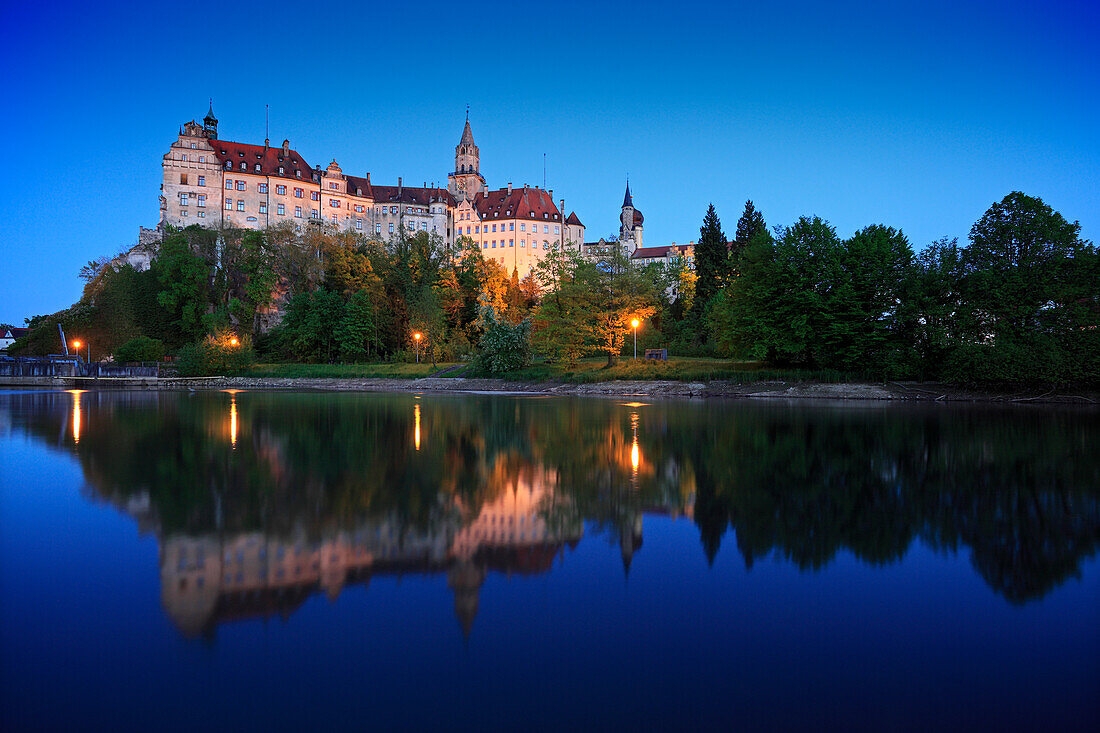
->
161, 474, 691, 636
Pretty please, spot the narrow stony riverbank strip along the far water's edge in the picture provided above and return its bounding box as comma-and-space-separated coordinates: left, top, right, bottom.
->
0, 376, 1100, 405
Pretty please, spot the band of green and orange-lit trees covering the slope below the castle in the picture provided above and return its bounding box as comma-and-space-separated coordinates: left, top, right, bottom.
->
13, 193, 1100, 386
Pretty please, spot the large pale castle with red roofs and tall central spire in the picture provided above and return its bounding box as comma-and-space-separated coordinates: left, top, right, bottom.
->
161, 105, 585, 277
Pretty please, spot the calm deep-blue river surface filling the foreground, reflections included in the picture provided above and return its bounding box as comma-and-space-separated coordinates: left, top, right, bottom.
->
0, 392, 1100, 731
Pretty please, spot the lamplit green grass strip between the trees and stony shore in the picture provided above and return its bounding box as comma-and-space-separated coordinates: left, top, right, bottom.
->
241, 357, 873, 384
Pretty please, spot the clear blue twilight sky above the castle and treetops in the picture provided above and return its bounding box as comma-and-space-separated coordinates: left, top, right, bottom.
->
0, 0, 1100, 325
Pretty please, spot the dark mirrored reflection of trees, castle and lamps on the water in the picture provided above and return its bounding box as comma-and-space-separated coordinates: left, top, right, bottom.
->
0, 393, 1100, 635
